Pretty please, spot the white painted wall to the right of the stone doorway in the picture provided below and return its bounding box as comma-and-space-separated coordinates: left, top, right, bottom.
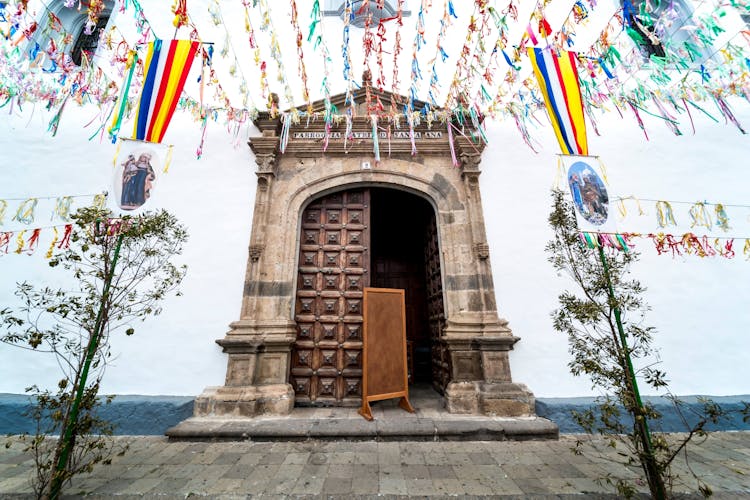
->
488, 97, 750, 397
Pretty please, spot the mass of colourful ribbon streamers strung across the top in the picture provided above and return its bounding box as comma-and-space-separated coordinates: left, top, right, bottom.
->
0, 0, 750, 152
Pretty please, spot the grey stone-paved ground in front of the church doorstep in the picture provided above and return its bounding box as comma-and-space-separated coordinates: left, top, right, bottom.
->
0, 432, 750, 498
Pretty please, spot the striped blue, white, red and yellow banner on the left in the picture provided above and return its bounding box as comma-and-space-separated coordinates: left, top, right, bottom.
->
133, 40, 198, 142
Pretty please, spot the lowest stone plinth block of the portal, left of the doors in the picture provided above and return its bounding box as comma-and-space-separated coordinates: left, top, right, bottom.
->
194, 384, 294, 418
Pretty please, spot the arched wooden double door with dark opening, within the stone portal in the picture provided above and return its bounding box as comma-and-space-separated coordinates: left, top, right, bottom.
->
290, 188, 442, 406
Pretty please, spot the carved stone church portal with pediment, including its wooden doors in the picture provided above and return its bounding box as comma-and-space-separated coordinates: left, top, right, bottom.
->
187, 89, 548, 424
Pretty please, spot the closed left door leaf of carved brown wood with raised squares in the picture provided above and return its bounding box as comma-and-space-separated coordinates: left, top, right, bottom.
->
290, 189, 370, 406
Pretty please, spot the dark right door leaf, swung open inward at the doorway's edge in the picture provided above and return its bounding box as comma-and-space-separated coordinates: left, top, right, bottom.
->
424, 217, 451, 393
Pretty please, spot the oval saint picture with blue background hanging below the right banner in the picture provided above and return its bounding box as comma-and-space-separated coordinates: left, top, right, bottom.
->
568, 161, 609, 226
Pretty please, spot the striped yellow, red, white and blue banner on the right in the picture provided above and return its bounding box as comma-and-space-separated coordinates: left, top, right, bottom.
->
528, 47, 588, 155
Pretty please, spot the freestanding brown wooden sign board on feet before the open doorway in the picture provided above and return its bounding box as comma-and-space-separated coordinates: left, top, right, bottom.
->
359, 287, 414, 420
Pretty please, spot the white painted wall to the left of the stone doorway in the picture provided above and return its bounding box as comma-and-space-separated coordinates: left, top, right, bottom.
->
0, 104, 255, 395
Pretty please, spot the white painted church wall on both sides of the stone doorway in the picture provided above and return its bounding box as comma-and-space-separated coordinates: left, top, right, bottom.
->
0, 96, 750, 397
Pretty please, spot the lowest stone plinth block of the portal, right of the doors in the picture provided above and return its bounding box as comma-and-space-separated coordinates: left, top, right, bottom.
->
445, 381, 535, 417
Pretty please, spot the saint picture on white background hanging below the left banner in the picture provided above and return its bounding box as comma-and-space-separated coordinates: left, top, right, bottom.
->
115, 145, 159, 210
